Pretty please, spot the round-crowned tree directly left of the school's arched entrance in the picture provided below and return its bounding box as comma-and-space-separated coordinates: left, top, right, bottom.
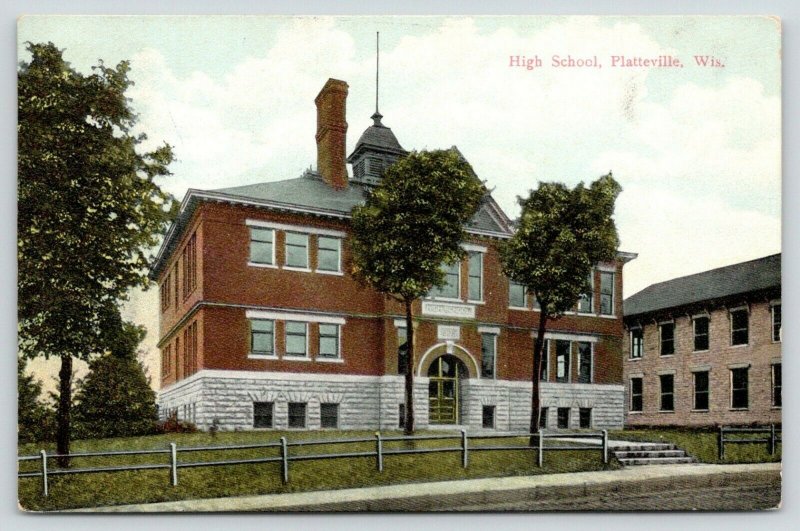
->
351, 150, 486, 434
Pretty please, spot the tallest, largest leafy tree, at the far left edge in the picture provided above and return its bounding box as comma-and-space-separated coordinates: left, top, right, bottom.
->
17, 43, 175, 466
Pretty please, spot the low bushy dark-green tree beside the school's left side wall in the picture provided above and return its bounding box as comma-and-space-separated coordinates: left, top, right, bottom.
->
73, 323, 158, 438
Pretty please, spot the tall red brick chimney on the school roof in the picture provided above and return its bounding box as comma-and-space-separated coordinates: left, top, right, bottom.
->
314, 79, 348, 190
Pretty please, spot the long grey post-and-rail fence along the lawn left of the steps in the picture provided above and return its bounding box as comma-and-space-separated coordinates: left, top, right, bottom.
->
17, 429, 608, 496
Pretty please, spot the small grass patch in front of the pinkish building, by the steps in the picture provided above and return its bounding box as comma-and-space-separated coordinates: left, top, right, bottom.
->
608, 428, 782, 464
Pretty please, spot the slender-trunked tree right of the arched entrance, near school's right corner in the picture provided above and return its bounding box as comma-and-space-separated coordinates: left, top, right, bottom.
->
500, 173, 622, 440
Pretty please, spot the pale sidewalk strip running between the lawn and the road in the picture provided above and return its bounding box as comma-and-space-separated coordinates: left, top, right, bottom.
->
74, 463, 781, 512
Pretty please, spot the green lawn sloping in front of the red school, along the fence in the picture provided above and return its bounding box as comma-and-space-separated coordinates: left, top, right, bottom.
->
18, 431, 619, 510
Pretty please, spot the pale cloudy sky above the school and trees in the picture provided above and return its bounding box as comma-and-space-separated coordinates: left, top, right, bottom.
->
18, 16, 781, 390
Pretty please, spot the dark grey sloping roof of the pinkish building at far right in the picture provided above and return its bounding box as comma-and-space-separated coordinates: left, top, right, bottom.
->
623, 253, 781, 318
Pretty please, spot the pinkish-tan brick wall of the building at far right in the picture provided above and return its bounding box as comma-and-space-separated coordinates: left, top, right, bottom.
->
623, 302, 781, 426
